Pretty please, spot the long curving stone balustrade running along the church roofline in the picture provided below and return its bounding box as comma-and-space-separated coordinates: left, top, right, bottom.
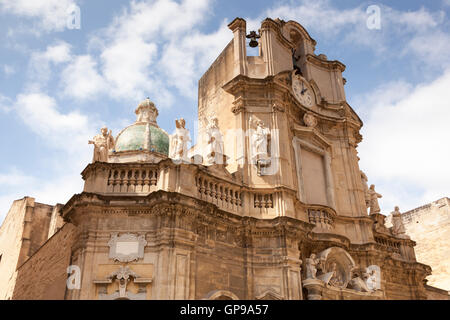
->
81, 159, 335, 221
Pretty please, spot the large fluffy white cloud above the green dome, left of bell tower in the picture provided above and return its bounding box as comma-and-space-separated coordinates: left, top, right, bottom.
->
82, 0, 220, 107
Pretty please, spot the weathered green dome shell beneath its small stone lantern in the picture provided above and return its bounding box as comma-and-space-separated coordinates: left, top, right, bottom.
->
115, 123, 169, 155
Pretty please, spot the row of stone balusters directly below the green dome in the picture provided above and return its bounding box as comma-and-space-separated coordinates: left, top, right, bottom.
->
107, 166, 159, 193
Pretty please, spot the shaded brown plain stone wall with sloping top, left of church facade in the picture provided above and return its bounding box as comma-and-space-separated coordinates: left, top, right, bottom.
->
13, 223, 76, 300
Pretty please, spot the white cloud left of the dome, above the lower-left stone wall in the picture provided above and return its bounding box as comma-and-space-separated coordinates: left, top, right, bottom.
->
0, 92, 100, 223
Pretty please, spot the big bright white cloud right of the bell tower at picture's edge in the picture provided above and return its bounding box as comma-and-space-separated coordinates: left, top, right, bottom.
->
359, 70, 450, 213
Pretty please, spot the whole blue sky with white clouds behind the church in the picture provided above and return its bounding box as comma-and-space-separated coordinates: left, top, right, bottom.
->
0, 0, 450, 221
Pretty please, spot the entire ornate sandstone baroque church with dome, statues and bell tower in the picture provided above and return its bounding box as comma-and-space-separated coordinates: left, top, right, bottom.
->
0, 18, 448, 300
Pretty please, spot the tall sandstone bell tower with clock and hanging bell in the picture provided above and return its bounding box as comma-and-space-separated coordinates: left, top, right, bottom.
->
199, 18, 367, 220
